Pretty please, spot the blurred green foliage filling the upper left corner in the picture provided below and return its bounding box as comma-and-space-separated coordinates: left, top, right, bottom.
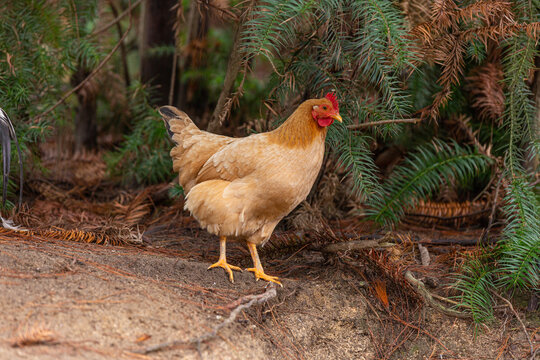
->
0, 0, 100, 207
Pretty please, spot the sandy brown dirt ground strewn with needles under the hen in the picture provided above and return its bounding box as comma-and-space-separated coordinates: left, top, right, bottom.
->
0, 225, 539, 360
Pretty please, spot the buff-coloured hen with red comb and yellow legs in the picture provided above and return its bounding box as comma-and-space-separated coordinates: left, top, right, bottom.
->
159, 93, 342, 285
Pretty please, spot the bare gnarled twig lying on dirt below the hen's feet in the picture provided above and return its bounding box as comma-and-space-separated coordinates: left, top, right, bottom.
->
136, 284, 277, 354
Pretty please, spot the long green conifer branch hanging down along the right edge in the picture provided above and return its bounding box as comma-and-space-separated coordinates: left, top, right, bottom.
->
497, 1, 540, 296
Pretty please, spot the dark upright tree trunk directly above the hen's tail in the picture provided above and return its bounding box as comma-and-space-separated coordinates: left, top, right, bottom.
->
140, 0, 177, 104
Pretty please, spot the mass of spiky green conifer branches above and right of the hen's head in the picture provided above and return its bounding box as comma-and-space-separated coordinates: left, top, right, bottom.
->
243, 0, 540, 321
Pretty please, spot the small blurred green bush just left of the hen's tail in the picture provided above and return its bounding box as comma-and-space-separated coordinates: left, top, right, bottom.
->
106, 83, 174, 185
